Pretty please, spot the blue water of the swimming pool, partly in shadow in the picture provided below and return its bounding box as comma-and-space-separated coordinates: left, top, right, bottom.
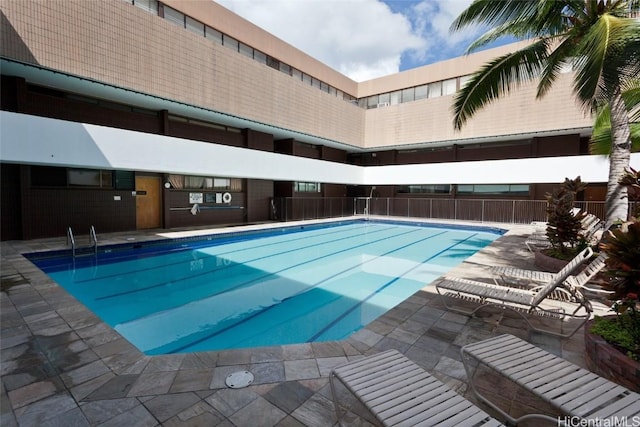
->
29, 221, 502, 355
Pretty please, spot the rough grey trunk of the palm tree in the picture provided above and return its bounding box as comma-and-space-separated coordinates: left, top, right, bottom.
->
605, 85, 631, 229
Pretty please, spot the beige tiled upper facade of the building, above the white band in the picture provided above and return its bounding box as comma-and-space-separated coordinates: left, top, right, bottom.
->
0, 0, 591, 149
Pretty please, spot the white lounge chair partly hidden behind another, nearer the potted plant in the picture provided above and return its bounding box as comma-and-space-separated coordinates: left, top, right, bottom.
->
492, 252, 613, 300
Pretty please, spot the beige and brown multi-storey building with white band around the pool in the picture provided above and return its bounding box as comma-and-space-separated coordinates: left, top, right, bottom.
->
0, 0, 640, 240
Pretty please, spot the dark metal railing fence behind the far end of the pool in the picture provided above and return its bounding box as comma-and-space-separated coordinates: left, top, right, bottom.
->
272, 197, 632, 224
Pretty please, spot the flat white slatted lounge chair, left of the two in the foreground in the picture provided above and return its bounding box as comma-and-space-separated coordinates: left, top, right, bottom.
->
329, 350, 502, 427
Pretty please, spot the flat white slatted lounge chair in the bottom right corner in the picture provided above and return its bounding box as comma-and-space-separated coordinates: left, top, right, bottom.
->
460, 335, 640, 426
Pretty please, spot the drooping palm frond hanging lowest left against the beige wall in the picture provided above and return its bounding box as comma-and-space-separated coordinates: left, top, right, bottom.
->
453, 41, 547, 130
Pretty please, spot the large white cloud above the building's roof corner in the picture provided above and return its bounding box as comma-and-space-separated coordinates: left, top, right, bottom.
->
216, 0, 427, 81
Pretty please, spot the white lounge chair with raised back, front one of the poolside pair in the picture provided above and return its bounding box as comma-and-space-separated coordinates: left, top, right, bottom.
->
436, 248, 593, 338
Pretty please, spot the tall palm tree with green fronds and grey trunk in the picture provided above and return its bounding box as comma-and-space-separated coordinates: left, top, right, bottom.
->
451, 0, 640, 231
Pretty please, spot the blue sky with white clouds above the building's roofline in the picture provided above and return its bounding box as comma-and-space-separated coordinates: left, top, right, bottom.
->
214, 0, 504, 81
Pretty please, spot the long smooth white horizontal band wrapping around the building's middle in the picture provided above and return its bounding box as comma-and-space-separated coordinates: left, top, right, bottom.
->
0, 111, 640, 185
